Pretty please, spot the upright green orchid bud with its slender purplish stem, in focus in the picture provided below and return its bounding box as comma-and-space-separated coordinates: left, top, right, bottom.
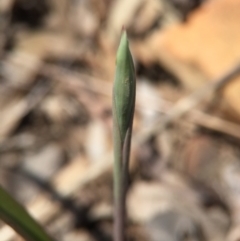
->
113, 30, 136, 241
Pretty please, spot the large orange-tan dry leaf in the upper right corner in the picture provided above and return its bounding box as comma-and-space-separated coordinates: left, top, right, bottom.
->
135, 0, 240, 119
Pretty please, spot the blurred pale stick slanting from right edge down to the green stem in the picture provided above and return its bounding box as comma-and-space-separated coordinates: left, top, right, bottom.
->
133, 64, 240, 145
